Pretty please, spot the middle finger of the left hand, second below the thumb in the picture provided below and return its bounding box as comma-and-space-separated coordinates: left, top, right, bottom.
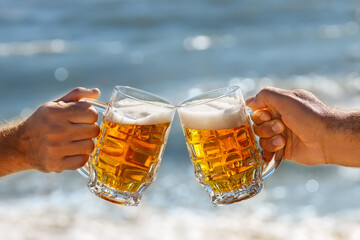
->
70, 123, 100, 141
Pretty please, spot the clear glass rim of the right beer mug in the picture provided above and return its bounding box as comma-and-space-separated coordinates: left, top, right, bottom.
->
177, 86, 241, 108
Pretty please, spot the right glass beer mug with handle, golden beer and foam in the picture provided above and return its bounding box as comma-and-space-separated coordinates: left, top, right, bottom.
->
177, 86, 283, 205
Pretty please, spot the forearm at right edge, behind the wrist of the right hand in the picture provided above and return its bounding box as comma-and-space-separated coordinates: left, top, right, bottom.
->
326, 111, 360, 167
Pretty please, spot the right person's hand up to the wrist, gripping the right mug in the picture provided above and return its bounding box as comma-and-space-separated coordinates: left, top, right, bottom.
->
246, 88, 337, 165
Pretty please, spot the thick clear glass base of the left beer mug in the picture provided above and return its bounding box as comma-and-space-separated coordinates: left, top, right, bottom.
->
88, 180, 141, 206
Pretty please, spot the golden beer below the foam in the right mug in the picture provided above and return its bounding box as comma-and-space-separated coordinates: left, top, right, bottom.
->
184, 124, 261, 201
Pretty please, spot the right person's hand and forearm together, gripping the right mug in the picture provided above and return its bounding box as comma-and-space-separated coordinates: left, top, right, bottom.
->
246, 87, 360, 167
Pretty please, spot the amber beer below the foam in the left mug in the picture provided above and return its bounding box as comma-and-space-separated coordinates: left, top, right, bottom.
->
90, 120, 170, 204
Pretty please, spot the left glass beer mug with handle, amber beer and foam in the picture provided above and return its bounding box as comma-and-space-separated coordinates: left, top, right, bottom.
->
78, 86, 175, 206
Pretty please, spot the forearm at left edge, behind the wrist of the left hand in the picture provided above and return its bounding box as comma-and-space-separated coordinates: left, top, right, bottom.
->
0, 121, 30, 177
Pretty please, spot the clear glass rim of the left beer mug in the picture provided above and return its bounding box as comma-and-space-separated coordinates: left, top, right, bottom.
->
114, 85, 176, 108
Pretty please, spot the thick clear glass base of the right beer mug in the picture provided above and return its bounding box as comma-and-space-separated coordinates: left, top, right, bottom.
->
203, 182, 263, 206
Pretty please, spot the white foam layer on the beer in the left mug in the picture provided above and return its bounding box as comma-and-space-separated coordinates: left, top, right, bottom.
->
105, 99, 174, 125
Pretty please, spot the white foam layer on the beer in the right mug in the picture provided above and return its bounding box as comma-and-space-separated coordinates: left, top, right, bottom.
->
178, 97, 248, 130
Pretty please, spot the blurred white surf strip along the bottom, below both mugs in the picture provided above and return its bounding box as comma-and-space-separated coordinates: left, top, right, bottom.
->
0, 197, 360, 240
